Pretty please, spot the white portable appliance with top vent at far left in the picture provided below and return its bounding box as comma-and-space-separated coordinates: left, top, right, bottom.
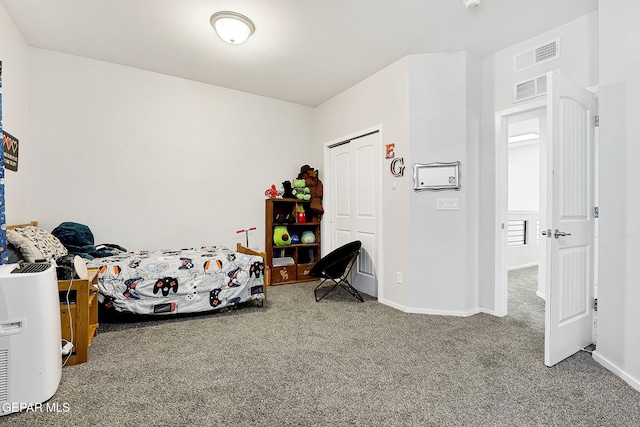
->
0, 263, 62, 416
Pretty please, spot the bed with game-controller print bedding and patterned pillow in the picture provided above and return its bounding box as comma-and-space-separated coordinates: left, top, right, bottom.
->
7, 221, 270, 315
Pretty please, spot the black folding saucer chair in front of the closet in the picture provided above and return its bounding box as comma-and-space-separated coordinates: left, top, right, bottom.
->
309, 240, 364, 302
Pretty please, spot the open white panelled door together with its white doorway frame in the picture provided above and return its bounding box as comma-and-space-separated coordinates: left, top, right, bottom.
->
495, 73, 596, 366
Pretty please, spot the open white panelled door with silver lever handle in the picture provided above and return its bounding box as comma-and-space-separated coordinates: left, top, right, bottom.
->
543, 73, 595, 366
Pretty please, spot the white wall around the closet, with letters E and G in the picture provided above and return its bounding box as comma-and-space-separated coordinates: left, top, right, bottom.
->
315, 58, 412, 307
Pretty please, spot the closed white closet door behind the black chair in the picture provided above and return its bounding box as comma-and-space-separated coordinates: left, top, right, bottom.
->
330, 132, 380, 297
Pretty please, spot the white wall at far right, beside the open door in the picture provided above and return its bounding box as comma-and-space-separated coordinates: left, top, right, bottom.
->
594, 0, 640, 390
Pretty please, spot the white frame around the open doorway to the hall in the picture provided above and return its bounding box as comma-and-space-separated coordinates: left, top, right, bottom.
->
493, 97, 547, 317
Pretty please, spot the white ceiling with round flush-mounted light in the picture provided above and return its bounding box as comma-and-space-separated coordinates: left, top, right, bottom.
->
0, 0, 598, 106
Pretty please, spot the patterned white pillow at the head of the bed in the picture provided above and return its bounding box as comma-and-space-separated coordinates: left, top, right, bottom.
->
7, 225, 69, 262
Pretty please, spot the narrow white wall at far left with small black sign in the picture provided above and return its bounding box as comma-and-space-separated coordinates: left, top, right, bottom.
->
0, 4, 30, 224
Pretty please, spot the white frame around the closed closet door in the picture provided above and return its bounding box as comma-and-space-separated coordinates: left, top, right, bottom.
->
320, 124, 384, 298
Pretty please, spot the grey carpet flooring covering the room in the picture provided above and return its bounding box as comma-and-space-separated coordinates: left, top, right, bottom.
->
0, 268, 640, 426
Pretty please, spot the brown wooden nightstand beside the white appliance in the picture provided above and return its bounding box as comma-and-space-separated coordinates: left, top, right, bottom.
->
58, 268, 98, 365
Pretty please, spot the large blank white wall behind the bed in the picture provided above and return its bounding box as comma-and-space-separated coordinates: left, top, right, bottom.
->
25, 49, 313, 249
